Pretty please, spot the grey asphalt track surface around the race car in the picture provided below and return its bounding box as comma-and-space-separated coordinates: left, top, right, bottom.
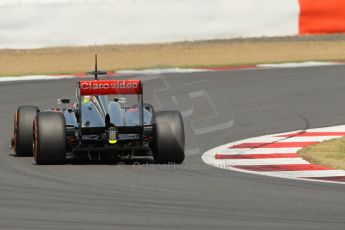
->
0, 66, 345, 230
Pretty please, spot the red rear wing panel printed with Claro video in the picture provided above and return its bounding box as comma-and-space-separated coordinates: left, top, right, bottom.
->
78, 80, 143, 96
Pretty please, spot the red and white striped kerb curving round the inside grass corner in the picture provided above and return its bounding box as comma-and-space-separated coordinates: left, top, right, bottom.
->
202, 125, 345, 183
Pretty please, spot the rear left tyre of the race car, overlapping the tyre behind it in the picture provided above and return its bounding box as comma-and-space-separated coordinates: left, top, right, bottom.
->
34, 112, 66, 165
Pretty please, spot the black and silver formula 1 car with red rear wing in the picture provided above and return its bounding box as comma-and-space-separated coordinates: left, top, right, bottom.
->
11, 66, 185, 164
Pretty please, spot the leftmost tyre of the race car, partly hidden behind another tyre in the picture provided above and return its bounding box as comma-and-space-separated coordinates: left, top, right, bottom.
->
12, 105, 39, 156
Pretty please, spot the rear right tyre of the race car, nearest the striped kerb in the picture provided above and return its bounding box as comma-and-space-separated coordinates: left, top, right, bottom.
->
152, 111, 185, 164
